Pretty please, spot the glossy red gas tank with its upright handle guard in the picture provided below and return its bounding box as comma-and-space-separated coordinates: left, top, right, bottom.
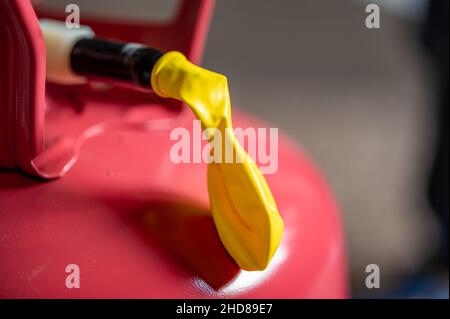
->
0, 0, 348, 298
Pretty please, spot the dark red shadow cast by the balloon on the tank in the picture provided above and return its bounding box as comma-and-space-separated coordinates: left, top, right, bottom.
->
133, 200, 239, 289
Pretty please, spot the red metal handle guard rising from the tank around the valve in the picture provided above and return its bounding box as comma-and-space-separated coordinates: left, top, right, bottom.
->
0, 0, 214, 178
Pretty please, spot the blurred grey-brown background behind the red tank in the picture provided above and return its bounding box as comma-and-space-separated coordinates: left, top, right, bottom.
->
37, 0, 448, 298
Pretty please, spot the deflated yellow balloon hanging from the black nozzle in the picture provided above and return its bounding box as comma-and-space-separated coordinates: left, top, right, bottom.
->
151, 51, 284, 270
